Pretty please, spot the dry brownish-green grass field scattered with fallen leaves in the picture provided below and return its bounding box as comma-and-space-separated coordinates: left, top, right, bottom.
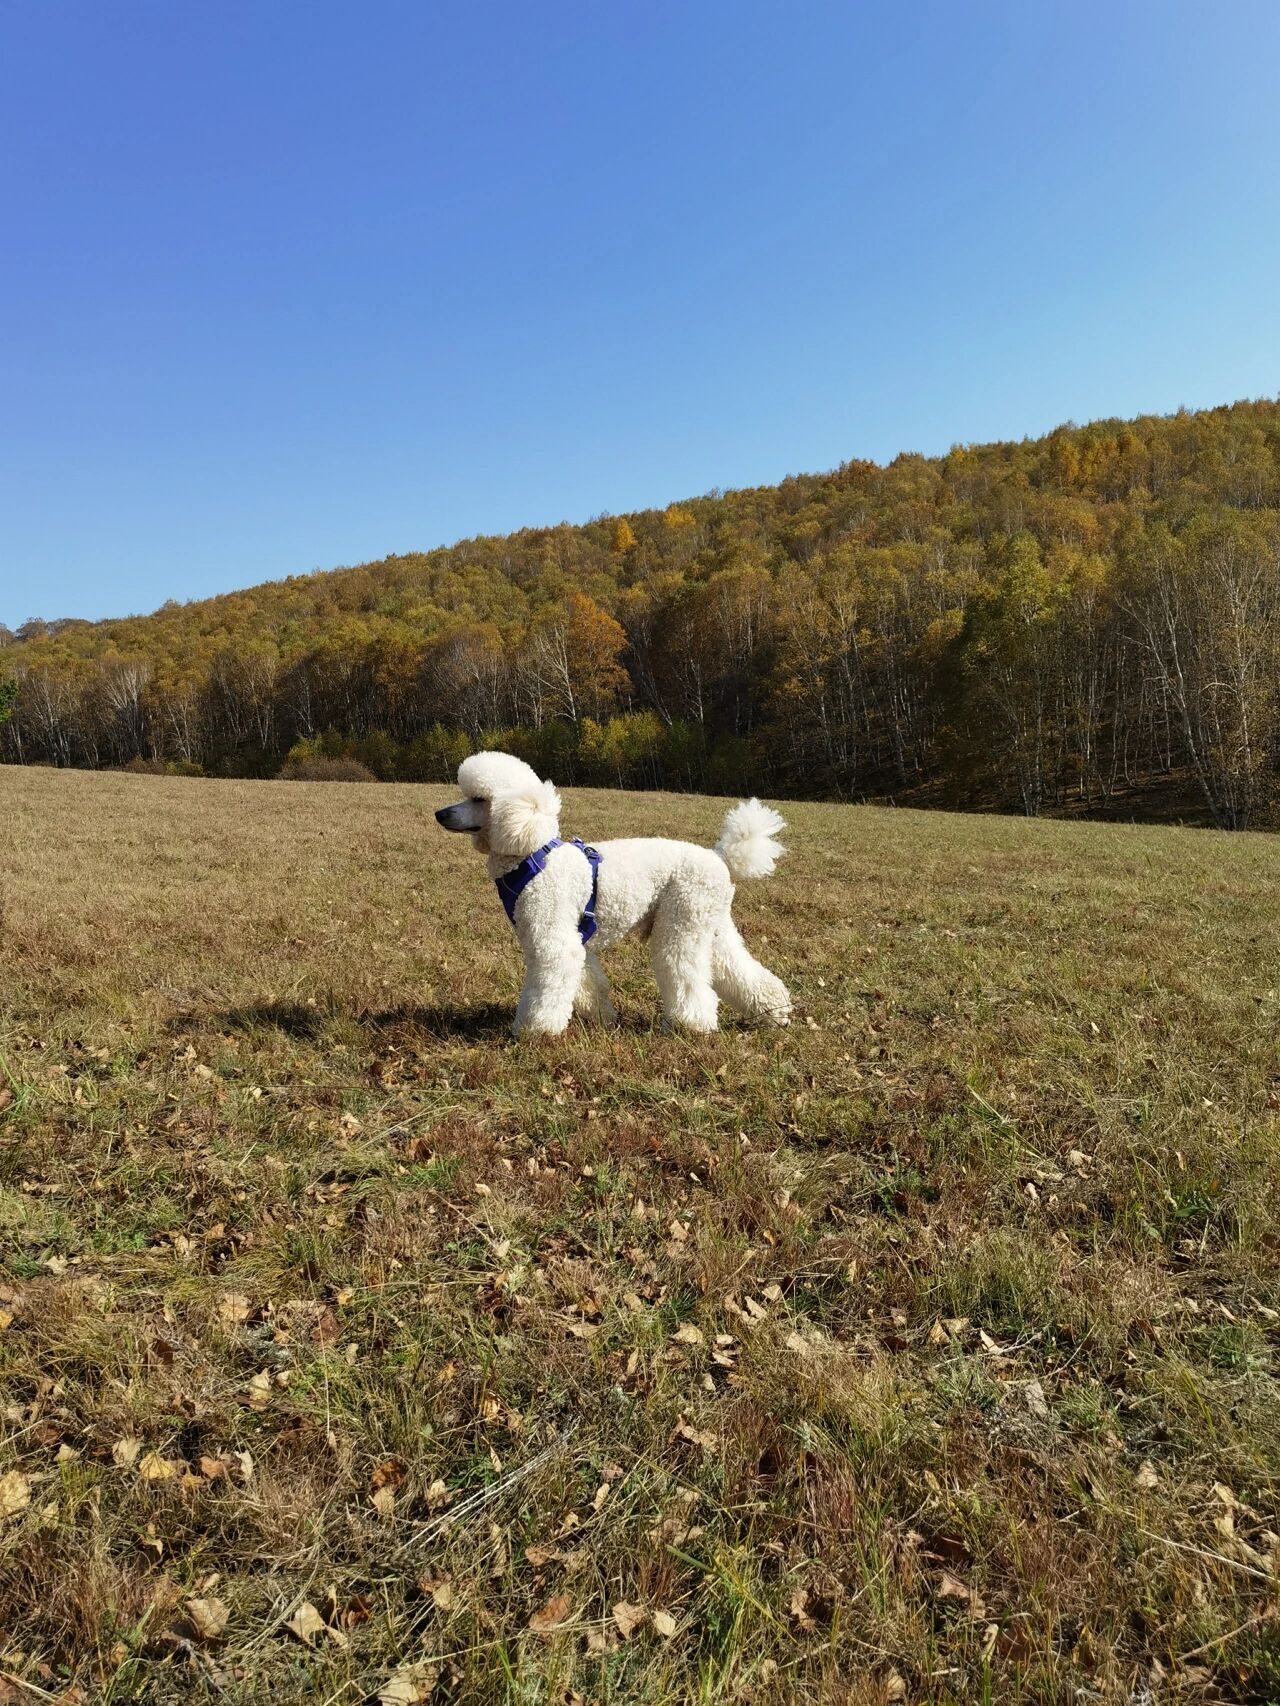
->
0, 769, 1280, 1706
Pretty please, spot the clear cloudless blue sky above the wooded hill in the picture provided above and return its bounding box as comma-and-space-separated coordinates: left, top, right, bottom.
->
0, 0, 1280, 626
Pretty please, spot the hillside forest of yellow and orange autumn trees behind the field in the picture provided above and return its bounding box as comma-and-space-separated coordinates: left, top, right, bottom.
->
0, 401, 1280, 829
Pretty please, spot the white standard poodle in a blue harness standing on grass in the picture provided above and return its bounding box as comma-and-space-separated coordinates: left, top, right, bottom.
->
435, 752, 792, 1036
